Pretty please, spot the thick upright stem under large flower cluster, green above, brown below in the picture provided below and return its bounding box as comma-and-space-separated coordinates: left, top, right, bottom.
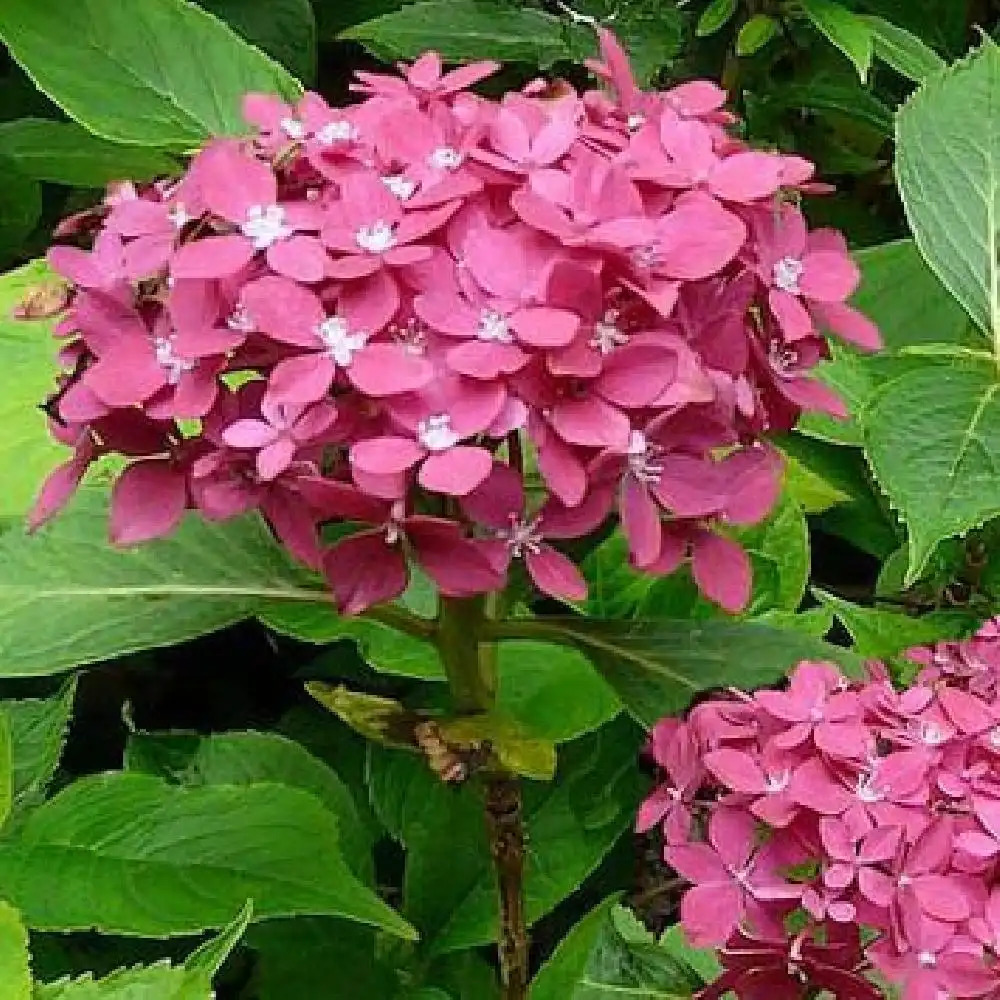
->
437, 598, 529, 1000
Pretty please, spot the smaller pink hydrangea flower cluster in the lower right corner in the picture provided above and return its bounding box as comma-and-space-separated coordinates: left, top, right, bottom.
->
638, 619, 1000, 1000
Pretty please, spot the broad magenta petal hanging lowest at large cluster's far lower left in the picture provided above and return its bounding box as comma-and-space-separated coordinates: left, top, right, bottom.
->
109, 459, 187, 545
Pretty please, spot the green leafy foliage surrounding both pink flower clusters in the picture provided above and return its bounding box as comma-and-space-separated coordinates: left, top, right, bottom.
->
0, 0, 1000, 1000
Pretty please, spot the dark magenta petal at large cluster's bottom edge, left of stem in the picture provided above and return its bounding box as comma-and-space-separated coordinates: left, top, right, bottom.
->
323, 530, 407, 615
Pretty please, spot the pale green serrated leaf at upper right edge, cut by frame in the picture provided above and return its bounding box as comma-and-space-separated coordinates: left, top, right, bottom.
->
896, 40, 1000, 355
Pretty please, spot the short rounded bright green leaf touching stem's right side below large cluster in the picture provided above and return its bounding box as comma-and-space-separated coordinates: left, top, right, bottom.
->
497, 641, 621, 743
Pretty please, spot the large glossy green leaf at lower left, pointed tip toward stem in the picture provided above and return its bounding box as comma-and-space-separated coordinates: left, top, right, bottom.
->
0, 773, 413, 937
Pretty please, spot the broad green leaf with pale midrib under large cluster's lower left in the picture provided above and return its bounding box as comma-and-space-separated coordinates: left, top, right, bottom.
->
0, 489, 350, 677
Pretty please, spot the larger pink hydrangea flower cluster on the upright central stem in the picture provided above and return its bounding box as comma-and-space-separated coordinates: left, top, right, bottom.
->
33, 34, 879, 613
